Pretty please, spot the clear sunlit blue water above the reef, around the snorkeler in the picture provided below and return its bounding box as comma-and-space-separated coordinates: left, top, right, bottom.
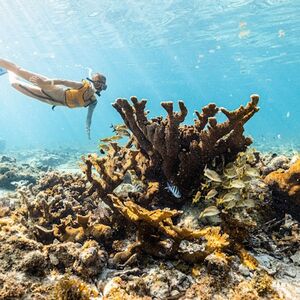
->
0, 0, 300, 150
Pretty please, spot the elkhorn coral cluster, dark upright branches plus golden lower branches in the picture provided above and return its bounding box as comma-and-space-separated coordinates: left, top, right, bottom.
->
82, 95, 259, 270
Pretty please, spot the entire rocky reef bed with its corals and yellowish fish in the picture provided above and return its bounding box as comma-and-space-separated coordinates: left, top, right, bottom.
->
0, 95, 300, 300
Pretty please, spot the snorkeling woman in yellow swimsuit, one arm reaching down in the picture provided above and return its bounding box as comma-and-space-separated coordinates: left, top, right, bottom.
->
0, 59, 107, 139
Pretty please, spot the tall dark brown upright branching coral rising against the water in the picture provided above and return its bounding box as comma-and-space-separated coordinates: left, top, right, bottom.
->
113, 95, 259, 188
